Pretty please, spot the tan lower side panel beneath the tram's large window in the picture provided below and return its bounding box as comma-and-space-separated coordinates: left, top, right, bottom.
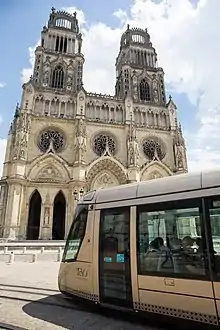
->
138, 276, 217, 325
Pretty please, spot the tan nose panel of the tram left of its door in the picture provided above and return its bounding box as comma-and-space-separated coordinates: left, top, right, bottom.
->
59, 206, 94, 300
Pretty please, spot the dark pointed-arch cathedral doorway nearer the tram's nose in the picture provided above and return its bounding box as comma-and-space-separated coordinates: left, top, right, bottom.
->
52, 191, 66, 240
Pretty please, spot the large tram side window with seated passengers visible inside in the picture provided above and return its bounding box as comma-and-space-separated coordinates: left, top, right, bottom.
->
137, 200, 207, 278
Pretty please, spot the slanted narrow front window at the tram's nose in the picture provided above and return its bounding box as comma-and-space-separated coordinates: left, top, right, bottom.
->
63, 205, 88, 261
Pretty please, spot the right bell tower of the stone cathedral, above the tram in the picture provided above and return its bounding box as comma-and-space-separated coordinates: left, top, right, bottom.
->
115, 25, 166, 106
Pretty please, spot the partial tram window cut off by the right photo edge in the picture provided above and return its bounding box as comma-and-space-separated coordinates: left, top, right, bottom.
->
206, 197, 220, 280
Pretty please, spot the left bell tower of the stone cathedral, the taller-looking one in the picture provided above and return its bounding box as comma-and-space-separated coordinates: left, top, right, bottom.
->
32, 8, 84, 94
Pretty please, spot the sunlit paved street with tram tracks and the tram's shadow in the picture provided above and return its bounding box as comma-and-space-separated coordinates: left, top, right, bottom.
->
0, 261, 162, 330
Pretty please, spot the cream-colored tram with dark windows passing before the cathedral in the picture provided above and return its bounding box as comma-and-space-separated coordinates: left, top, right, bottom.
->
58, 171, 220, 326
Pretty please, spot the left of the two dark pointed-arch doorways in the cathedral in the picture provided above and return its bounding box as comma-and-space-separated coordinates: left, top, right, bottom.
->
26, 190, 41, 240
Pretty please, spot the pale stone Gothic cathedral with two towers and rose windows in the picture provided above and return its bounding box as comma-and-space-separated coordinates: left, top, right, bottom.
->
0, 8, 187, 240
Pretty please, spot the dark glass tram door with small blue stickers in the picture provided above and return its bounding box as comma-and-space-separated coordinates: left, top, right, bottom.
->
99, 208, 132, 308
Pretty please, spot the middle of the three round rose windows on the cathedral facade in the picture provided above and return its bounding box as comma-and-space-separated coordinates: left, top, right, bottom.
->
93, 134, 116, 156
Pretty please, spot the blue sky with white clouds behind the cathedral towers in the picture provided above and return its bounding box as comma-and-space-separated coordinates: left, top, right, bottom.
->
0, 0, 220, 177
